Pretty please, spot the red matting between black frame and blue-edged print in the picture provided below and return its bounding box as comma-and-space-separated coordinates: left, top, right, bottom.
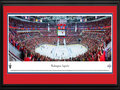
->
3, 6, 117, 84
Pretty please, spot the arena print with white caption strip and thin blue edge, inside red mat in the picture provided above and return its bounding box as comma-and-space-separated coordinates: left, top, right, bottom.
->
7, 13, 113, 74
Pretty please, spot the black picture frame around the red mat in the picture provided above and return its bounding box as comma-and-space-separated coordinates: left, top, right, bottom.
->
0, 0, 120, 90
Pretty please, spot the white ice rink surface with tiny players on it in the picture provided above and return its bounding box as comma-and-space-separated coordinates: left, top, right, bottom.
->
35, 44, 87, 59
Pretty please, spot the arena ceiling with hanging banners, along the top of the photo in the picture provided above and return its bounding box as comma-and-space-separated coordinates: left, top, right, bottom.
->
11, 16, 109, 23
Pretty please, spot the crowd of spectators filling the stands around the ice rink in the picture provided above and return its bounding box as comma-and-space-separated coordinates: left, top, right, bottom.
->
9, 18, 111, 61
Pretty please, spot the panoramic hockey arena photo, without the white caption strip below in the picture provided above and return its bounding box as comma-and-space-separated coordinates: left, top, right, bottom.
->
8, 15, 112, 61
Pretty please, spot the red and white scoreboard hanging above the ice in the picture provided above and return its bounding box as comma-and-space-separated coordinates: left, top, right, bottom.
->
57, 24, 66, 36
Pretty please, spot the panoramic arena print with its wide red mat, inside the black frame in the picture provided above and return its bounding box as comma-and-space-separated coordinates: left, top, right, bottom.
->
0, 2, 118, 89
